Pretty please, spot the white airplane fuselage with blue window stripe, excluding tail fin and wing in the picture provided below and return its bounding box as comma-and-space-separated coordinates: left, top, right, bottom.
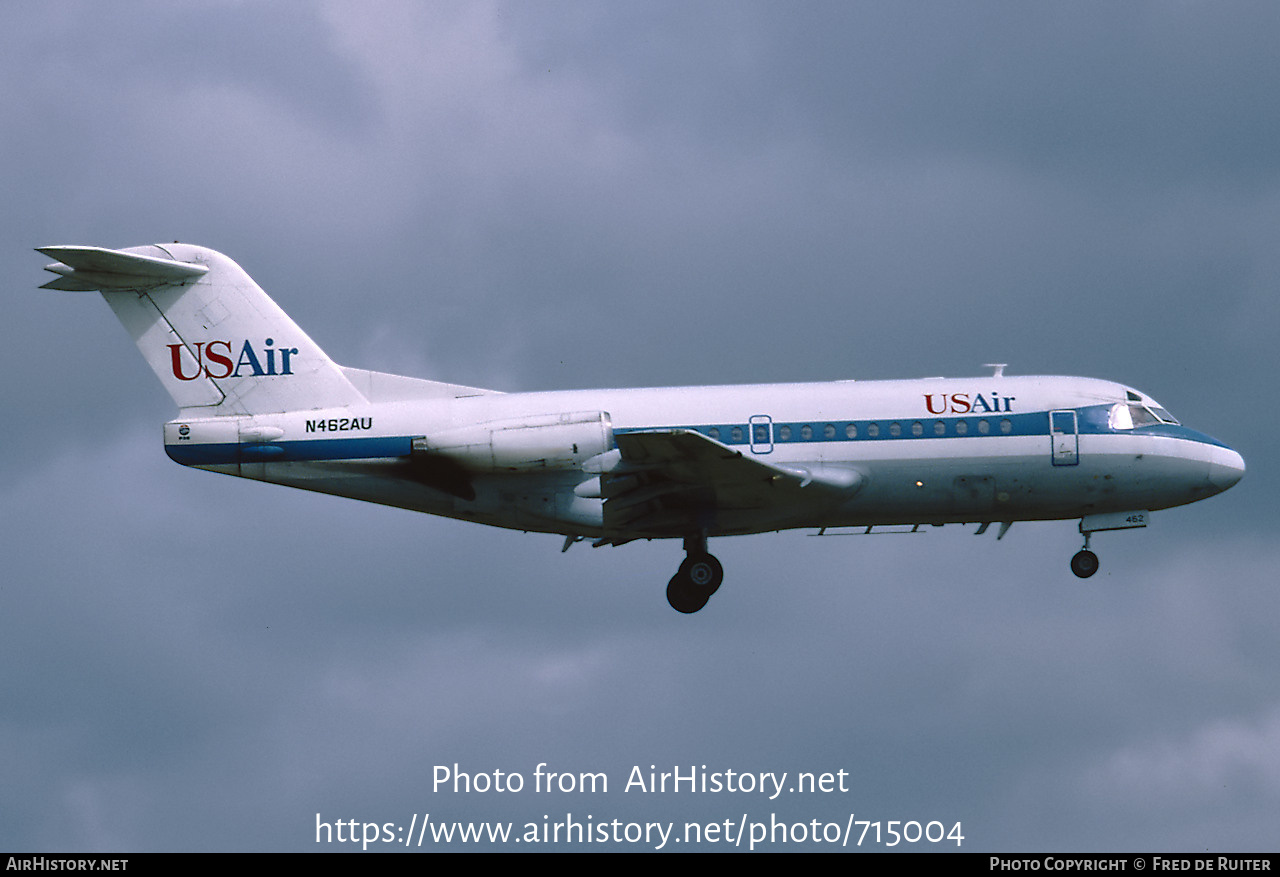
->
165, 376, 1244, 540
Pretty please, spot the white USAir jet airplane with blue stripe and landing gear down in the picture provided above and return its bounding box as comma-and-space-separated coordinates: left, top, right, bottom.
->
38, 243, 1244, 613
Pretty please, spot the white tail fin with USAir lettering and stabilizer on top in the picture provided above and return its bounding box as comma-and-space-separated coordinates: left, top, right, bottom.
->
40, 243, 365, 415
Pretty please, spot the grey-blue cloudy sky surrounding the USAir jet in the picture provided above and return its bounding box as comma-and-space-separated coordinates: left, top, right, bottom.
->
0, 0, 1280, 851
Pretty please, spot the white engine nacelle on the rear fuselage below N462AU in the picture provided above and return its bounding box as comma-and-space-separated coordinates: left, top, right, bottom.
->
413, 411, 613, 472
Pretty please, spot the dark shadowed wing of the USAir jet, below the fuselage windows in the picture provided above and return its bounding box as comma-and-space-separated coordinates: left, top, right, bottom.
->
600, 429, 861, 543
